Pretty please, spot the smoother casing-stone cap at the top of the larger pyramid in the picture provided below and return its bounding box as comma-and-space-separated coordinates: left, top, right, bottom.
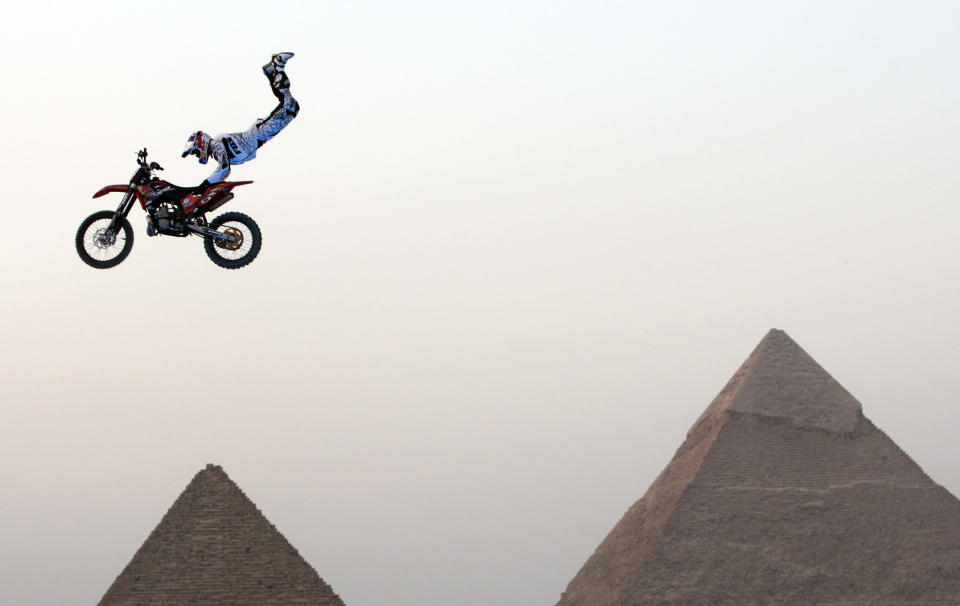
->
711, 328, 862, 434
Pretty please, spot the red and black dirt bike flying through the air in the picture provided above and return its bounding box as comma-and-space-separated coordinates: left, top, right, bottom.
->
76, 148, 262, 269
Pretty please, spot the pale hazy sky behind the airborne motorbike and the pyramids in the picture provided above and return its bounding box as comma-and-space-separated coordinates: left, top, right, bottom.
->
0, 0, 960, 606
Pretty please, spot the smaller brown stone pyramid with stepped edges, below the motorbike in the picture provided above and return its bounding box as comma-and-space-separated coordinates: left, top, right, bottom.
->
99, 465, 343, 606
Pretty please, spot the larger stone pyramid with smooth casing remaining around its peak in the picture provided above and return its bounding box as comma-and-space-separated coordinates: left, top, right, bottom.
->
557, 330, 960, 606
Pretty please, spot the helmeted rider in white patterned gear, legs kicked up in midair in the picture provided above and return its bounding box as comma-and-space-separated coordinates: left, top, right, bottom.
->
181, 53, 300, 191
